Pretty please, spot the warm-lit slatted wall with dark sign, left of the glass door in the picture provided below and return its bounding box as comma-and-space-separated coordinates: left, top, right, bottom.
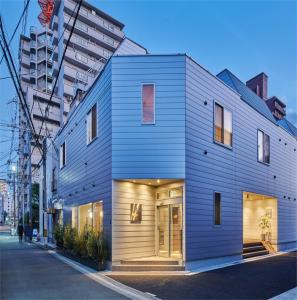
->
112, 181, 156, 261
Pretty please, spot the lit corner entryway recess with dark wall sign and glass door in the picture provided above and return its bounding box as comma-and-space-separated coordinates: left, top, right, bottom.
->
112, 179, 184, 262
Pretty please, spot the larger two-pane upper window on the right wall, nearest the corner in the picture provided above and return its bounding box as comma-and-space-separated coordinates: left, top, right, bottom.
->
214, 103, 233, 147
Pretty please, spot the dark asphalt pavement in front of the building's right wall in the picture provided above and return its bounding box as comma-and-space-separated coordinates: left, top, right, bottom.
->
110, 252, 297, 300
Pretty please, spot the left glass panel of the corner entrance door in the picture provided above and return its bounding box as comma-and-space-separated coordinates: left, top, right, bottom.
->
158, 205, 169, 257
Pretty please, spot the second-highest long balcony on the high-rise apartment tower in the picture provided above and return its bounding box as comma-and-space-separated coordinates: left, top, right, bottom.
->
64, 15, 119, 52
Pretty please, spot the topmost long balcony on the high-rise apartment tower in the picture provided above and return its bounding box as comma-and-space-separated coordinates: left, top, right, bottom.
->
64, 1, 125, 41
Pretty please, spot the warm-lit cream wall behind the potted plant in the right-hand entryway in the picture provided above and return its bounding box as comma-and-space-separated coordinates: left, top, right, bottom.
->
243, 198, 277, 244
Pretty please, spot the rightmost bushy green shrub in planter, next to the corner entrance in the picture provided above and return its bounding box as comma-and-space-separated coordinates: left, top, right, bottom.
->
87, 231, 108, 264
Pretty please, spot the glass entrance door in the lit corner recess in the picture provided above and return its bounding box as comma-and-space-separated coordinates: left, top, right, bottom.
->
157, 204, 183, 257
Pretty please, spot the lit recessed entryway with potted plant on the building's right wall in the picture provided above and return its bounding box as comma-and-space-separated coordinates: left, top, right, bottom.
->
243, 192, 278, 250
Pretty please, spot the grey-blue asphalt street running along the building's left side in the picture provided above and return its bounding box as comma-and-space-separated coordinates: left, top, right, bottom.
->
0, 231, 126, 300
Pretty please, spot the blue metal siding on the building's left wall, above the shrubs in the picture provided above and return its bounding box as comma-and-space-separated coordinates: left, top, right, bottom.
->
56, 64, 111, 244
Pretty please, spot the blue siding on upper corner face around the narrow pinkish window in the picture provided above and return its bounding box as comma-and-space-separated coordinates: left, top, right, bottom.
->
112, 56, 185, 179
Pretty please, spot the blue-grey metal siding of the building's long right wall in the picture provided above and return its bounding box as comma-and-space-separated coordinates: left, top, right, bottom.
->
186, 58, 297, 260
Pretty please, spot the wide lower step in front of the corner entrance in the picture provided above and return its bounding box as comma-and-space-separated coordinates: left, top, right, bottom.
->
111, 265, 185, 272
